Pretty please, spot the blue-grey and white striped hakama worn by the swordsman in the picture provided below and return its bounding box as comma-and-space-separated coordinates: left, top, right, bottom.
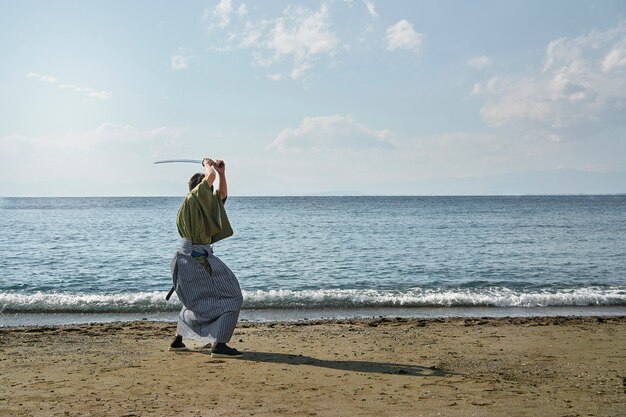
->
171, 238, 243, 343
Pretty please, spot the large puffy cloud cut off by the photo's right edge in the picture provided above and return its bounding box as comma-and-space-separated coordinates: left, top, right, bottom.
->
473, 24, 626, 141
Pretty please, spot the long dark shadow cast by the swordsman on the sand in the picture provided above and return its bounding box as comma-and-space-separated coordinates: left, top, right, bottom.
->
195, 350, 452, 377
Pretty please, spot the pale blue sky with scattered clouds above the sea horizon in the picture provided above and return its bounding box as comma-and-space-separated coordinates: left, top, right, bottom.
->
0, 0, 626, 197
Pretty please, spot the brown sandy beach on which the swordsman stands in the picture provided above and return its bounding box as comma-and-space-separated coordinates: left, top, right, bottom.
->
0, 317, 626, 416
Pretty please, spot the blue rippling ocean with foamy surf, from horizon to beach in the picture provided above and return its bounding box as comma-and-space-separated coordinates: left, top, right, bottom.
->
0, 195, 626, 326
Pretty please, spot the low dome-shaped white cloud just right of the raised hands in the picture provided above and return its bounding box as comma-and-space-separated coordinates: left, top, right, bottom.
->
269, 114, 391, 150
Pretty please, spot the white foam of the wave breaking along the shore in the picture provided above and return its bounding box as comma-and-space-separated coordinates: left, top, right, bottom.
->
0, 287, 626, 313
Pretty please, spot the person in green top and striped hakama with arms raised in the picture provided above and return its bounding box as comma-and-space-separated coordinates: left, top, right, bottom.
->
167, 158, 243, 357
